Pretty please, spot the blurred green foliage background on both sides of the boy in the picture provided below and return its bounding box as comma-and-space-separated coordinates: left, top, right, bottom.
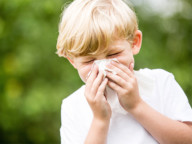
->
0, 0, 192, 144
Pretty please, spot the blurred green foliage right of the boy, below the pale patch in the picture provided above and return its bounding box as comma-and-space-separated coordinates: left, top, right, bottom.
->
135, 0, 192, 105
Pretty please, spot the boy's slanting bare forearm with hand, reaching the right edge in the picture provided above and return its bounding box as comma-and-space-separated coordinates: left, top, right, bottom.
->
107, 63, 192, 144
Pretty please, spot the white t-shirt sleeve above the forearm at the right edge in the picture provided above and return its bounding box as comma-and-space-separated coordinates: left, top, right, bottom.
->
164, 74, 192, 122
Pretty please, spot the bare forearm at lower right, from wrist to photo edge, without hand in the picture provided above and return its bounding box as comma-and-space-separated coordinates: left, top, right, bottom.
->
129, 101, 192, 144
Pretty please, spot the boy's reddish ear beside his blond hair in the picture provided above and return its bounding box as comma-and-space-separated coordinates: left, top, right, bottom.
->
132, 30, 142, 55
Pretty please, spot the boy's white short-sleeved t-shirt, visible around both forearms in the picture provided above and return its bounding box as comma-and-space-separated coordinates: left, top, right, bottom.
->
60, 69, 192, 144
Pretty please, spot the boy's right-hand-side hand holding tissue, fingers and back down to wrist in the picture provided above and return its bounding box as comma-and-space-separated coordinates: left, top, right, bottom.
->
107, 61, 141, 112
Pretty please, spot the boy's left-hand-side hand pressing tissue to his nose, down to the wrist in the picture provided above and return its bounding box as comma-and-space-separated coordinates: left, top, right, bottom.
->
85, 65, 111, 120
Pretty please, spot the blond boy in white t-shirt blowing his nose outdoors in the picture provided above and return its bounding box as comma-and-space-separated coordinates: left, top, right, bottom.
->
57, 0, 192, 144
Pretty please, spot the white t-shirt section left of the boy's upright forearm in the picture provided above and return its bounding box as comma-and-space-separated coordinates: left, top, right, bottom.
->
60, 86, 92, 144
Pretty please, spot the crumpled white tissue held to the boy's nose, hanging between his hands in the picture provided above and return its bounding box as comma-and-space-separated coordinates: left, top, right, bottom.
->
94, 59, 127, 115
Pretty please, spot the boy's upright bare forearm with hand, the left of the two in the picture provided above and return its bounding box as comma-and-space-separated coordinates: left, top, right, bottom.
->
85, 66, 111, 144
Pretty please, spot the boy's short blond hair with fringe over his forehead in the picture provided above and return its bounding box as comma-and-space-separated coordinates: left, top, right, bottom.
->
57, 0, 138, 57
